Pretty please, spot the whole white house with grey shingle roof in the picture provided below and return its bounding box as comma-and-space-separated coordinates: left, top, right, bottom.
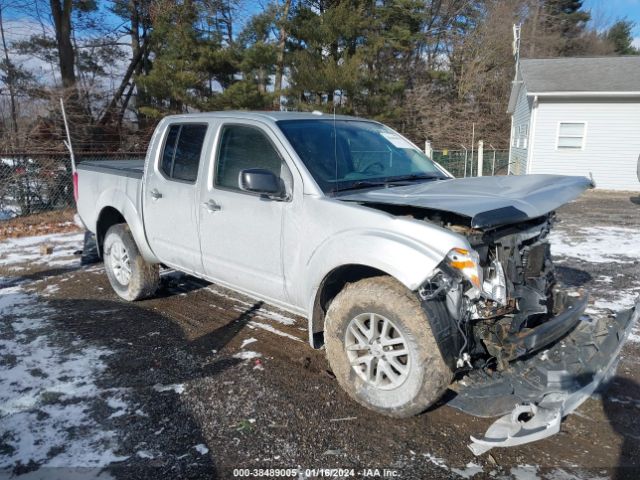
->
508, 56, 640, 191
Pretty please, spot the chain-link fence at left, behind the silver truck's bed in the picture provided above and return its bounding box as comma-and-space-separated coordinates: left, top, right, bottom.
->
0, 152, 145, 220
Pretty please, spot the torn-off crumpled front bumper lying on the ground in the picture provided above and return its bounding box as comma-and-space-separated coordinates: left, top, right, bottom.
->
448, 297, 640, 455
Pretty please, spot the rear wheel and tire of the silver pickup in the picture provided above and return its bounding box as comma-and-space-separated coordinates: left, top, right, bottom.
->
103, 223, 160, 302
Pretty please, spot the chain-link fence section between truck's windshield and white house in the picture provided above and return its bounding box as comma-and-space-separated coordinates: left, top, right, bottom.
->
432, 148, 509, 178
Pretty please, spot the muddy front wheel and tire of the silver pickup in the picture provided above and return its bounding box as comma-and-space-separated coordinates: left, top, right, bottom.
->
324, 277, 453, 418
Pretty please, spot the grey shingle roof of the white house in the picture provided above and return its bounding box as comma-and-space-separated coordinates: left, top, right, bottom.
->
508, 56, 640, 112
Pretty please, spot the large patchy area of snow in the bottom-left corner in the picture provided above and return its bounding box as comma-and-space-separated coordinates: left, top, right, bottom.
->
0, 286, 127, 469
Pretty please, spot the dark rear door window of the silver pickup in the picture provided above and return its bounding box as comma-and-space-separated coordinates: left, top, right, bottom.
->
160, 123, 207, 183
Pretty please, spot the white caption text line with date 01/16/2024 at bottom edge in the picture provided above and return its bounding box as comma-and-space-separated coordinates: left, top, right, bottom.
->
233, 467, 400, 478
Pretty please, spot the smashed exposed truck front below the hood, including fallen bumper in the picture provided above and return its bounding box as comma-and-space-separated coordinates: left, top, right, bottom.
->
420, 213, 638, 454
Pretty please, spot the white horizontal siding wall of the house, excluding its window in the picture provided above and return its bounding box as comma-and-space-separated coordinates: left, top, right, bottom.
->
528, 98, 640, 191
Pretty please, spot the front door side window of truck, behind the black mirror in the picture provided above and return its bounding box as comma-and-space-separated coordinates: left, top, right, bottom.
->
215, 125, 283, 191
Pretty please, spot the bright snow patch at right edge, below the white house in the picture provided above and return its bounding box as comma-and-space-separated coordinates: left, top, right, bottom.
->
549, 227, 640, 263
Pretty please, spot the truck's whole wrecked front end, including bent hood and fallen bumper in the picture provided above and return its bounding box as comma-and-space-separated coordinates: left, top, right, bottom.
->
338, 176, 640, 455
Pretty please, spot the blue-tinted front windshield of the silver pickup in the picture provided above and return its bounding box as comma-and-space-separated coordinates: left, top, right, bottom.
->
278, 119, 449, 193
